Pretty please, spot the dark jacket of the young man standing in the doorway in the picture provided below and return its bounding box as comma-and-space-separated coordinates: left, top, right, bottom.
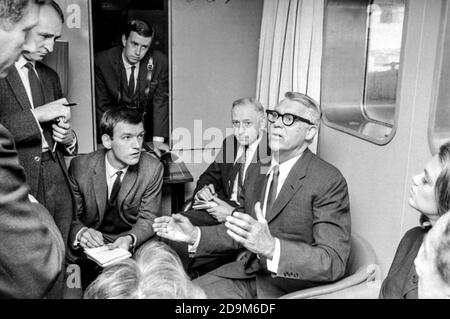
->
95, 46, 169, 138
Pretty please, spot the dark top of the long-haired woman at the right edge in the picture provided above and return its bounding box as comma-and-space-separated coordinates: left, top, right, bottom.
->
380, 227, 429, 299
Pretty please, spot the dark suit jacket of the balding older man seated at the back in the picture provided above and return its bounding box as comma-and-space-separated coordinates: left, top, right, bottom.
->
193, 131, 270, 201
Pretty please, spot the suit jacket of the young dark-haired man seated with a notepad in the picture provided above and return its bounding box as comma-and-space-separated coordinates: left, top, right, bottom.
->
69, 149, 163, 248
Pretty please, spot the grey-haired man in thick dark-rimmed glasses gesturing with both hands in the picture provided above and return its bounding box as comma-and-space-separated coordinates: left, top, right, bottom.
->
153, 92, 350, 298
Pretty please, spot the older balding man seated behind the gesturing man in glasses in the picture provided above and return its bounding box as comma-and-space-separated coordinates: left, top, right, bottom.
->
185, 98, 267, 226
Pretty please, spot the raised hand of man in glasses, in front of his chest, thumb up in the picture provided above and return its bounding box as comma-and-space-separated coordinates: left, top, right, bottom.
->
225, 202, 275, 259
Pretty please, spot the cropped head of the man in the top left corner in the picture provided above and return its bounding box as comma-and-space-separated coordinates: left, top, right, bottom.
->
0, 0, 39, 78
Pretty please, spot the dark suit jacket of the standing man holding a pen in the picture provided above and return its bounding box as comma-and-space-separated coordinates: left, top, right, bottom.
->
0, 62, 76, 196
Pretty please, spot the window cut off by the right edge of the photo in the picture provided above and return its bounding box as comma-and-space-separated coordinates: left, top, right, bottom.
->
429, 3, 450, 154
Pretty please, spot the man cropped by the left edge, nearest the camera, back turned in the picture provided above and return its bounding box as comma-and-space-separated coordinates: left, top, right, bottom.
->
0, 0, 64, 298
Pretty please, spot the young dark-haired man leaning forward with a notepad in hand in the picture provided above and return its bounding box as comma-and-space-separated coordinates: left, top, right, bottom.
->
69, 108, 163, 283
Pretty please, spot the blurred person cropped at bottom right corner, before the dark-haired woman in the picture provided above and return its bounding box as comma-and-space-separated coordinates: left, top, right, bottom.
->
414, 213, 450, 299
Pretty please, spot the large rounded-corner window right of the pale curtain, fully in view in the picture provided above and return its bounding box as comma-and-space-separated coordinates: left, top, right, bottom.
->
321, 0, 405, 145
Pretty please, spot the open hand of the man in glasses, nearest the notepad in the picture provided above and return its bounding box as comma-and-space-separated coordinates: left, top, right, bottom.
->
153, 214, 196, 244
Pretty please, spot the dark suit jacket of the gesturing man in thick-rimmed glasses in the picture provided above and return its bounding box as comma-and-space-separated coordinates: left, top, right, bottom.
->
193, 149, 351, 298
